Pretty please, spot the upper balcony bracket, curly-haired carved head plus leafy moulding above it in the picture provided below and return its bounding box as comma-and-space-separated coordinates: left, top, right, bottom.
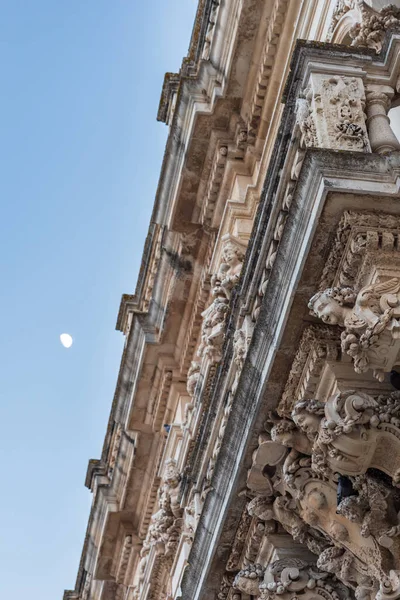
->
309, 212, 400, 381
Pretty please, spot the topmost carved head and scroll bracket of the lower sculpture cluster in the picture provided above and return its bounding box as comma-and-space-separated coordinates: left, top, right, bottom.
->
292, 390, 400, 485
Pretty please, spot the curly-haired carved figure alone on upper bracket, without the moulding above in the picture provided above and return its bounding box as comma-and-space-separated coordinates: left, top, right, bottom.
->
308, 277, 400, 381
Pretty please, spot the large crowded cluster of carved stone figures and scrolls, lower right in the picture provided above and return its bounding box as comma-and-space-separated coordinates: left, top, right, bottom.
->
247, 390, 400, 599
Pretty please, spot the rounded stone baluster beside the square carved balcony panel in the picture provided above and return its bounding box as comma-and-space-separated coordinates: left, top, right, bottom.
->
367, 85, 400, 154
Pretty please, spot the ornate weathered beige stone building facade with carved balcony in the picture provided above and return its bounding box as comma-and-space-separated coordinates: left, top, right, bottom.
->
64, 0, 400, 600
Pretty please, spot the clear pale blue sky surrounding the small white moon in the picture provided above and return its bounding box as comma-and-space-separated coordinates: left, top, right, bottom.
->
0, 0, 197, 600
